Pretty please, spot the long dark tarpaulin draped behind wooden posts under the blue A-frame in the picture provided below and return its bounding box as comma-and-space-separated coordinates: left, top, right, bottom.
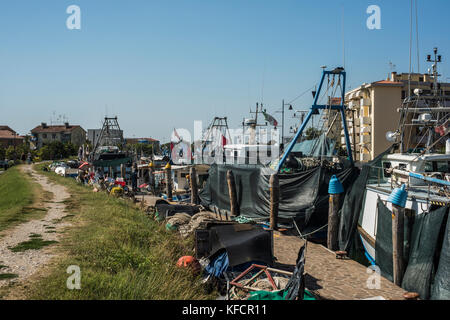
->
200, 164, 359, 231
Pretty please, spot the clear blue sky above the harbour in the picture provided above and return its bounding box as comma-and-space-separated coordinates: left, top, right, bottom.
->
0, 0, 450, 142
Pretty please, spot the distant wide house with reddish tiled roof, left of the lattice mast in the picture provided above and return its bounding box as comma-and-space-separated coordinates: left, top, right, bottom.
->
31, 122, 86, 148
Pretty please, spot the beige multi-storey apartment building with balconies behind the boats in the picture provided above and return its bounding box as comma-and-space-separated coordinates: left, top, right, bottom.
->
341, 72, 450, 162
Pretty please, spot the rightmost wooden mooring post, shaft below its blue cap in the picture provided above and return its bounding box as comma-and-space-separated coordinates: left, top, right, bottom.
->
392, 204, 405, 286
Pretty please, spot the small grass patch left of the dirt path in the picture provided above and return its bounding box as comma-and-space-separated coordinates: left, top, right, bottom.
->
0, 166, 51, 231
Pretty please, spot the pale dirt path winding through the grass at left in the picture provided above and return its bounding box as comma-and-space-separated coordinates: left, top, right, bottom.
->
0, 165, 70, 298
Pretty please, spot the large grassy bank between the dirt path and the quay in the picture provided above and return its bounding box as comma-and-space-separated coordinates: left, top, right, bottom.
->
27, 165, 215, 300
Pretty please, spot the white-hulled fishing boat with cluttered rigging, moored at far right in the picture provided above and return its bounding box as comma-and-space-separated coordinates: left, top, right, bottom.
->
352, 48, 450, 299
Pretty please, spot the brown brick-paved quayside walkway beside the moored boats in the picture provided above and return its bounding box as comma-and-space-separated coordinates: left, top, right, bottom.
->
274, 232, 406, 300
